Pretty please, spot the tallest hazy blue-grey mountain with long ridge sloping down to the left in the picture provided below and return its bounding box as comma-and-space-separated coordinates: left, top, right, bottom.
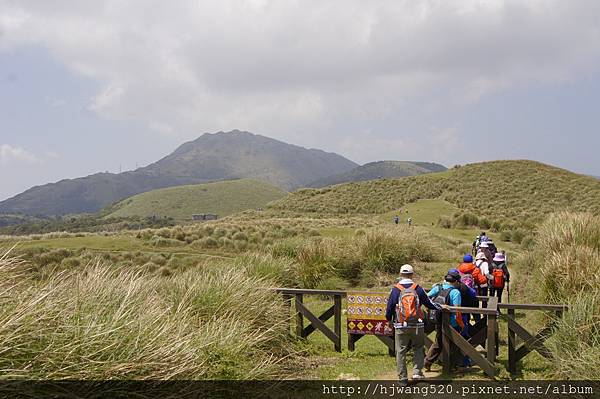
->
0, 130, 358, 216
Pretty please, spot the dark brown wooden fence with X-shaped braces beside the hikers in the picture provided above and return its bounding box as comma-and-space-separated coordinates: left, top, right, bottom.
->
273, 288, 567, 378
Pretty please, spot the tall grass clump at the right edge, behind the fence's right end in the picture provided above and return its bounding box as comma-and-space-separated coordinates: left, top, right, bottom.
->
533, 212, 600, 380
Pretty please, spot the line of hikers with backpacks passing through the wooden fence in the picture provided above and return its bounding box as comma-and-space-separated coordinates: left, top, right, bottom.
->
386, 232, 510, 385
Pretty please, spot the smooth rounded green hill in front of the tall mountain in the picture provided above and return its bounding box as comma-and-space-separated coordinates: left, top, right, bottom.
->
103, 179, 287, 220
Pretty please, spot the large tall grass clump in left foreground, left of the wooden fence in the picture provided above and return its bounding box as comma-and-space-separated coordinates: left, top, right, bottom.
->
0, 253, 292, 380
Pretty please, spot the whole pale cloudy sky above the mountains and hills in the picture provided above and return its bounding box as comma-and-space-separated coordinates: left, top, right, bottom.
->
0, 0, 600, 200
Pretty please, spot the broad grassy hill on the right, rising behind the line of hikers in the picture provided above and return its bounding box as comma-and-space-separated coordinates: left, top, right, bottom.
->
270, 161, 600, 228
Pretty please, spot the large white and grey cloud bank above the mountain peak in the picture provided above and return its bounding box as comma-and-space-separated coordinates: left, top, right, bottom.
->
0, 0, 600, 158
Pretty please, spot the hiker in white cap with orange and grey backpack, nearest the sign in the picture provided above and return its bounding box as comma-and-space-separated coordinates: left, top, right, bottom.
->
385, 265, 441, 385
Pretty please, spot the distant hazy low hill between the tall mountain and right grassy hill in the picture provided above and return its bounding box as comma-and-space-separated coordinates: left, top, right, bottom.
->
308, 161, 446, 187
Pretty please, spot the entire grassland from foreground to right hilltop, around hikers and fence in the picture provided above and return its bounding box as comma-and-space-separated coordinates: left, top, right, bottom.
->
0, 162, 600, 379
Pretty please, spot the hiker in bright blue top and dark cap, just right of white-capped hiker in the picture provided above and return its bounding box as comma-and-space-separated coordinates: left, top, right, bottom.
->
424, 274, 469, 371
